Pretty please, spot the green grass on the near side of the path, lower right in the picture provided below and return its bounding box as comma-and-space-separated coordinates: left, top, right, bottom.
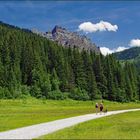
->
40, 111, 140, 139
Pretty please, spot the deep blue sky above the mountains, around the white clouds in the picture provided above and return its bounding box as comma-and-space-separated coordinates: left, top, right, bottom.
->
0, 0, 140, 54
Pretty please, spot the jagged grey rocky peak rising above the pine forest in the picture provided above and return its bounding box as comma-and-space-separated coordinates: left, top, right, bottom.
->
34, 26, 100, 53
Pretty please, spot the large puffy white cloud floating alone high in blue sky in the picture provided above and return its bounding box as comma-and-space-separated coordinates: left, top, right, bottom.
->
78, 21, 118, 33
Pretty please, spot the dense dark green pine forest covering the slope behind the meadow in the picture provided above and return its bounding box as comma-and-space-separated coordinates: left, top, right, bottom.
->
0, 22, 140, 102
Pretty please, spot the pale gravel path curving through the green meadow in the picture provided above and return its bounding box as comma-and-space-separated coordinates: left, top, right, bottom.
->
0, 109, 140, 139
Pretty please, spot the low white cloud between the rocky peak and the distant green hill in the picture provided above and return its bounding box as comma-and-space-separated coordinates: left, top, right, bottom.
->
100, 46, 128, 56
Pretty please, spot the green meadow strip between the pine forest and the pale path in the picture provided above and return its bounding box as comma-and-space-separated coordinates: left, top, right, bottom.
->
0, 98, 140, 131
